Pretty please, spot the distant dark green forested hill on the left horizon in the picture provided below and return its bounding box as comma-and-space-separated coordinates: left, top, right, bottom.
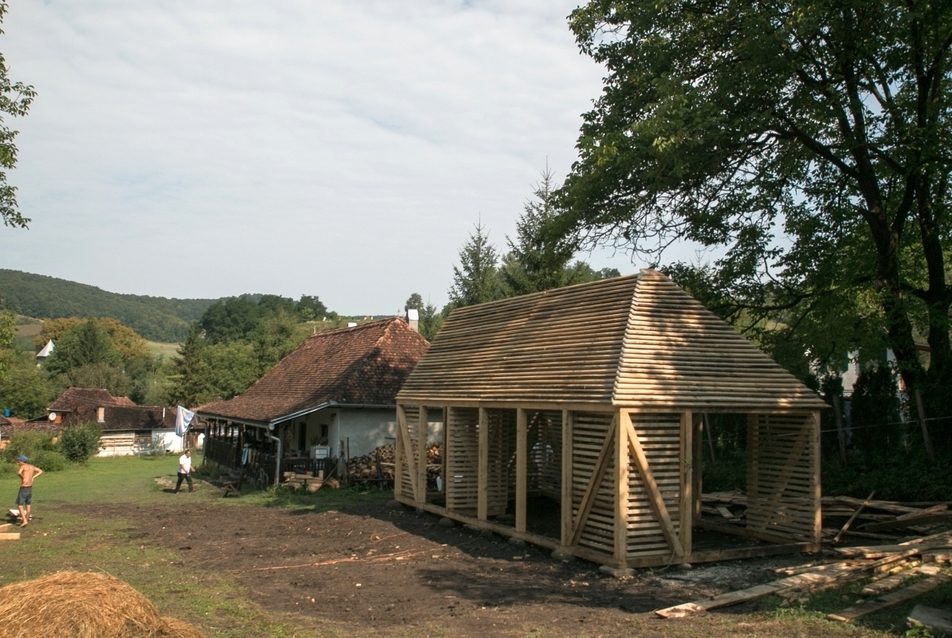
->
0, 269, 218, 343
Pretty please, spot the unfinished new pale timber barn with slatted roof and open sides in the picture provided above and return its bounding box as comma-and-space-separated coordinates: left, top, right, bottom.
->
395, 270, 826, 568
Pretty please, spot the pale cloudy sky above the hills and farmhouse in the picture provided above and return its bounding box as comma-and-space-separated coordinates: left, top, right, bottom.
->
0, 0, 643, 315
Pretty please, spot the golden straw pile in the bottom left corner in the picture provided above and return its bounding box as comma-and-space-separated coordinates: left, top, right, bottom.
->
0, 572, 205, 638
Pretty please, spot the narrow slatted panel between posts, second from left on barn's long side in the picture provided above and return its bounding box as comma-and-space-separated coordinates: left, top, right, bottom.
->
444, 408, 479, 514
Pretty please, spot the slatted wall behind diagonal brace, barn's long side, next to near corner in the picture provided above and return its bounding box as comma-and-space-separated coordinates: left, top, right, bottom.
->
572, 412, 615, 558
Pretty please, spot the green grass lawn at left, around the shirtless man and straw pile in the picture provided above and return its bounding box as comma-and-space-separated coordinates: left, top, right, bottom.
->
0, 456, 344, 637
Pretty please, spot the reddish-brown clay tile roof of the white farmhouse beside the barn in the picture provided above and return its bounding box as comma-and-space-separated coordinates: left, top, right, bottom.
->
197, 318, 429, 422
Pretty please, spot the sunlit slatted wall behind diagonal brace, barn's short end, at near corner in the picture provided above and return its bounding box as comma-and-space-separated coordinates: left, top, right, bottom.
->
627, 412, 681, 558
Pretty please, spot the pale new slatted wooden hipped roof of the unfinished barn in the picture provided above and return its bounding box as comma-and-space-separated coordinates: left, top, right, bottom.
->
398, 270, 825, 411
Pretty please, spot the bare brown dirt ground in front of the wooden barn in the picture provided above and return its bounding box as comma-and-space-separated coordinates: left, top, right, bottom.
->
54, 494, 856, 636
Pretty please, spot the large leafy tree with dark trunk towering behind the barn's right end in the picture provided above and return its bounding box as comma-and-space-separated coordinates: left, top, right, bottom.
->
552, 0, 952, 396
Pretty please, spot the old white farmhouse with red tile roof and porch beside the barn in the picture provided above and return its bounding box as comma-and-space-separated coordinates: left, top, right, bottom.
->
196, 318, 429, 482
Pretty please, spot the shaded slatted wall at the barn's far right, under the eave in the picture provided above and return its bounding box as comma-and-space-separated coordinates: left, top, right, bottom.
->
747, 414, 820, 541
